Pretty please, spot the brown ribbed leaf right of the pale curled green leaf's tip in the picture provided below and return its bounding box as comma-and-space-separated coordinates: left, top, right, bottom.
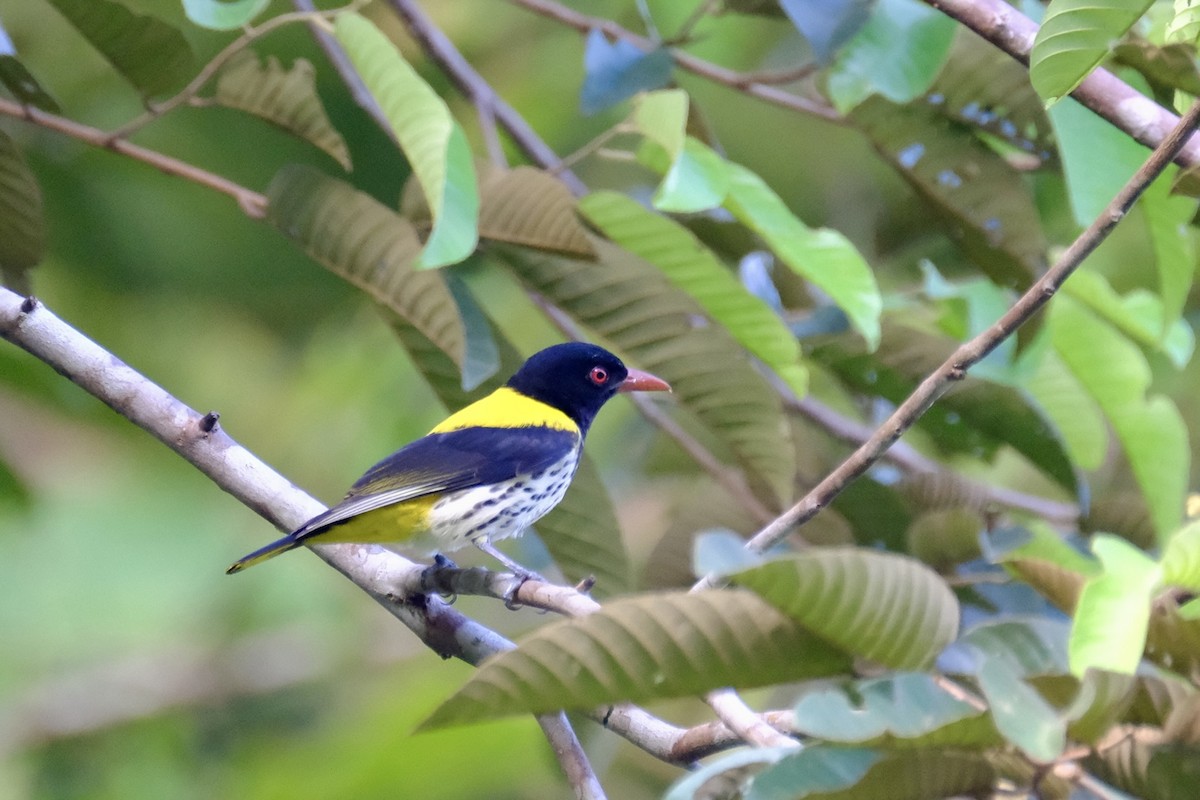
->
479, 166, 595, 258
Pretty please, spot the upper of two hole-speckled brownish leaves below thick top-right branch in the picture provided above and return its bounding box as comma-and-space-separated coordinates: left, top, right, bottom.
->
926, 29, 1054, 155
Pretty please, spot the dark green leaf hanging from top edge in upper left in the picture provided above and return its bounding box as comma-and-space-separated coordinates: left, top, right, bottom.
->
49, 0, 192, 97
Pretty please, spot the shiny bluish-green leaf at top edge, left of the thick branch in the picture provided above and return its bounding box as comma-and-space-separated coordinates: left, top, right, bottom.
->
827, 0, 955, 114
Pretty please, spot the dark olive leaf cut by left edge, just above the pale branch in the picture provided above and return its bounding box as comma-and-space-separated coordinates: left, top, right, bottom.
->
0, 131, 46, 294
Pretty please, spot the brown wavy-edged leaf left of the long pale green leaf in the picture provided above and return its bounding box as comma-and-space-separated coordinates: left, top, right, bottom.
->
215, 50, 350, 170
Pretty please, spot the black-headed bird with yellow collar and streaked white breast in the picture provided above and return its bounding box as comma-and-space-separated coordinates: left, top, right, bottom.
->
226, 342, 671, 577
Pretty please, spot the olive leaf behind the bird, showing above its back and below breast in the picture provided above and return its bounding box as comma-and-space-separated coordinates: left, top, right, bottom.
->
385, 303, 631, 597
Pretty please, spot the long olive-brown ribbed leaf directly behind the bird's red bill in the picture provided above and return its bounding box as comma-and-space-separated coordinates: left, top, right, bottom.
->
503, 241, 796, 505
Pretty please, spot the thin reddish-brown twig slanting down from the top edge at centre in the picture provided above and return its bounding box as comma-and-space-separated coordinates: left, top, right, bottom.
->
511, 0, 846, 125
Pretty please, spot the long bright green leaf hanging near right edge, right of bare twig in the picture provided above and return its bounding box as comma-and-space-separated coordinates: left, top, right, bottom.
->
1048, 296, 1190, 541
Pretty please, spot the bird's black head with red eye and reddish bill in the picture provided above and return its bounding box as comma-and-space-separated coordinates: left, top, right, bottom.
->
509, 342, 670, 433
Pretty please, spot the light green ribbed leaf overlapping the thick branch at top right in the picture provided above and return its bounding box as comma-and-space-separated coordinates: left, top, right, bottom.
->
1030, 0, 1152, 107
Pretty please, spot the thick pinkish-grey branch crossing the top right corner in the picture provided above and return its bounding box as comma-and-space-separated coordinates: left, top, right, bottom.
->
925, 0, 1200, 167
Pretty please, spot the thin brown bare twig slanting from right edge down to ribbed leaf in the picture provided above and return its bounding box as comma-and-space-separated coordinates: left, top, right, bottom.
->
715, 102, 1200, 573
